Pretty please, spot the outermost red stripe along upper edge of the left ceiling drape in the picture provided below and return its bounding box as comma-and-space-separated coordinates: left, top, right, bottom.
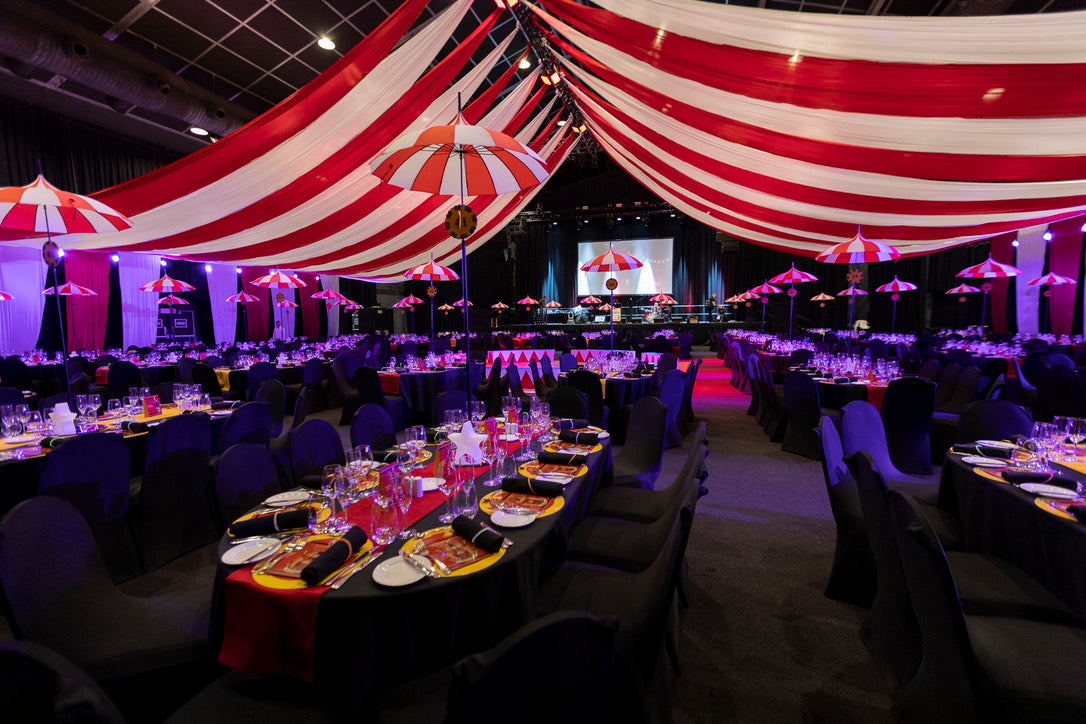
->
91, 0, 427, 216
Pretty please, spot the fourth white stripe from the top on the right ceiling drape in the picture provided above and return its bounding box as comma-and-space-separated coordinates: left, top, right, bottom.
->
573, 82, 1086, 233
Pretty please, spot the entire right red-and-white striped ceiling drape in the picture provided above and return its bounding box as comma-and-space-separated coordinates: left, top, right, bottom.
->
526, 0, 1086, 256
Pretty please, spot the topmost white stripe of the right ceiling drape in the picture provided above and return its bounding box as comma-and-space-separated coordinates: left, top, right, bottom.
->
596, 0, 1086, 65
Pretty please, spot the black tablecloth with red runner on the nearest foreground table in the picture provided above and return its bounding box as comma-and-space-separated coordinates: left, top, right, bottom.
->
212, 429, 611, 711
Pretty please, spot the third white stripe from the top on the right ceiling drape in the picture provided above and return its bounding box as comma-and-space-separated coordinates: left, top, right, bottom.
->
570, 68, 1086, 202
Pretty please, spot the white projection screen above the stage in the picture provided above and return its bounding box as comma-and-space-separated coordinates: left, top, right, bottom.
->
577, 239, 674, 297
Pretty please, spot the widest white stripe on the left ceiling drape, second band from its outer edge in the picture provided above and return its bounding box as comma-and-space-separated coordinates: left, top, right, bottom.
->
55, 0, 470, 251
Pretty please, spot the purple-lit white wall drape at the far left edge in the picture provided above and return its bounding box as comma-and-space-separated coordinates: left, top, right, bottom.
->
0, 244, 46, 355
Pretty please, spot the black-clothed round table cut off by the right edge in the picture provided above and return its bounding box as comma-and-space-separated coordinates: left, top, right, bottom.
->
939, 454, 1086, 618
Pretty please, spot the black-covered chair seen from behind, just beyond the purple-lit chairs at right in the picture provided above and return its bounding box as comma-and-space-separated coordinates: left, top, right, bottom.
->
880, 377, 935, 475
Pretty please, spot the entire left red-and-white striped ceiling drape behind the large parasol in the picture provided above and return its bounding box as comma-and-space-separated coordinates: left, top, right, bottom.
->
21, 0, 576, 281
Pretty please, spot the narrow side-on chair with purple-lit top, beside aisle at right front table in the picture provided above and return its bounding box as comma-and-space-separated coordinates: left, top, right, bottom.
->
819, 417, 875, 608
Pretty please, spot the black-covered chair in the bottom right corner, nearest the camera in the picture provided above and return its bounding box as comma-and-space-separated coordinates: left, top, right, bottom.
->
889, 493, 1086, 722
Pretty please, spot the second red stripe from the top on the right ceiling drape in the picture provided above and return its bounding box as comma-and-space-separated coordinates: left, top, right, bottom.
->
546, 34, 1086, 181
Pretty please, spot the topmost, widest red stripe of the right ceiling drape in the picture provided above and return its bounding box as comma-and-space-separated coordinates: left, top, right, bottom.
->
538, 0, 1086, 118
